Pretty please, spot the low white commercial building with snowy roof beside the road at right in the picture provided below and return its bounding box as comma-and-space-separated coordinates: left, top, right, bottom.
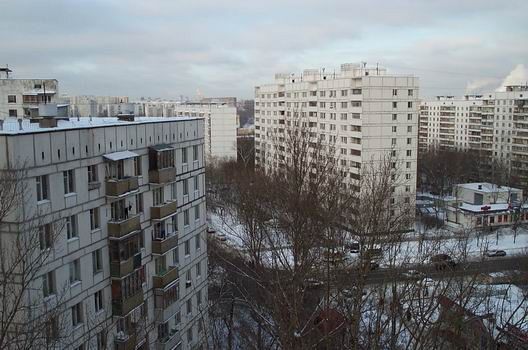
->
446, 182, 528, 228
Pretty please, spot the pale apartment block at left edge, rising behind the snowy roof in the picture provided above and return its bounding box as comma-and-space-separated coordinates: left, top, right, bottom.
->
0, 68, 68, 120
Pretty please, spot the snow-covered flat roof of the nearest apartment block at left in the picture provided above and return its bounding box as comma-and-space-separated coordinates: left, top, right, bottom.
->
0, 116, 202, 135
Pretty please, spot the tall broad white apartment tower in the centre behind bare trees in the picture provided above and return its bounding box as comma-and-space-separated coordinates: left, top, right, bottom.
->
255, 64, 419, 215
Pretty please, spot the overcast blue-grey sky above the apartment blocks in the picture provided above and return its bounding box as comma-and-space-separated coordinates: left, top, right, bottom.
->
0, 0, 528, 98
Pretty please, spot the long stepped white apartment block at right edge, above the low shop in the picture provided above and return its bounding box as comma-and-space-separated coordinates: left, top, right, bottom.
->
419, 86, 528, 184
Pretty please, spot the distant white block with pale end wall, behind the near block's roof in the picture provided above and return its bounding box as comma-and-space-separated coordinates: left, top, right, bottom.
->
142, 101, 239, 160
